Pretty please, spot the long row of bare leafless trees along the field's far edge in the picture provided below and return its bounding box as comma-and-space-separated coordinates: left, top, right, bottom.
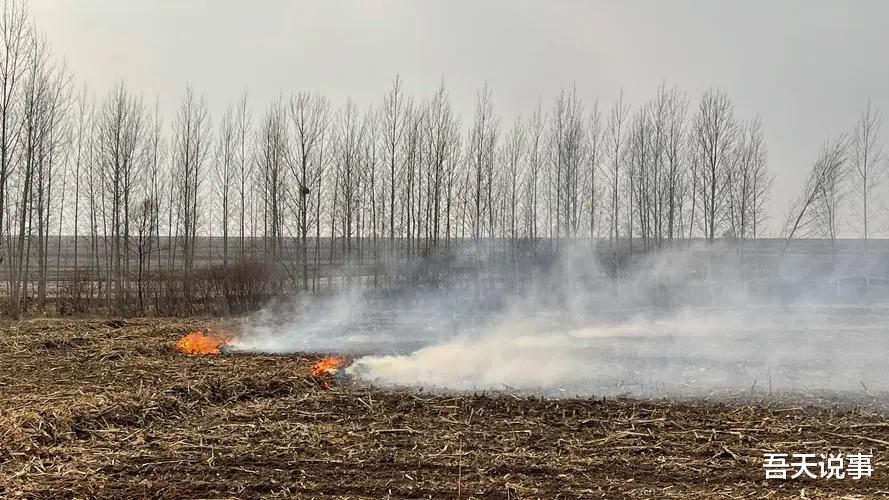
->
0, 0, 885, 317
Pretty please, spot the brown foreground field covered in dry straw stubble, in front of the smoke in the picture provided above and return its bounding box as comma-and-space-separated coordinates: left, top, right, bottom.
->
0, 319, 889, 498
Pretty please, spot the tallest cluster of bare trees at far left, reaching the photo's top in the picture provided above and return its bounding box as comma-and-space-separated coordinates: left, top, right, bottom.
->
0, 2, 71, 315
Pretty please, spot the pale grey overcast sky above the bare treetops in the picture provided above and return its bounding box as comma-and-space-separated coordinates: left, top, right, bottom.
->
31, 0, 889, 234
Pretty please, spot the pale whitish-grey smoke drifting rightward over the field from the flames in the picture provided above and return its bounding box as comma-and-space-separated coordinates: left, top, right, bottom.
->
236, 242, 889, 396
